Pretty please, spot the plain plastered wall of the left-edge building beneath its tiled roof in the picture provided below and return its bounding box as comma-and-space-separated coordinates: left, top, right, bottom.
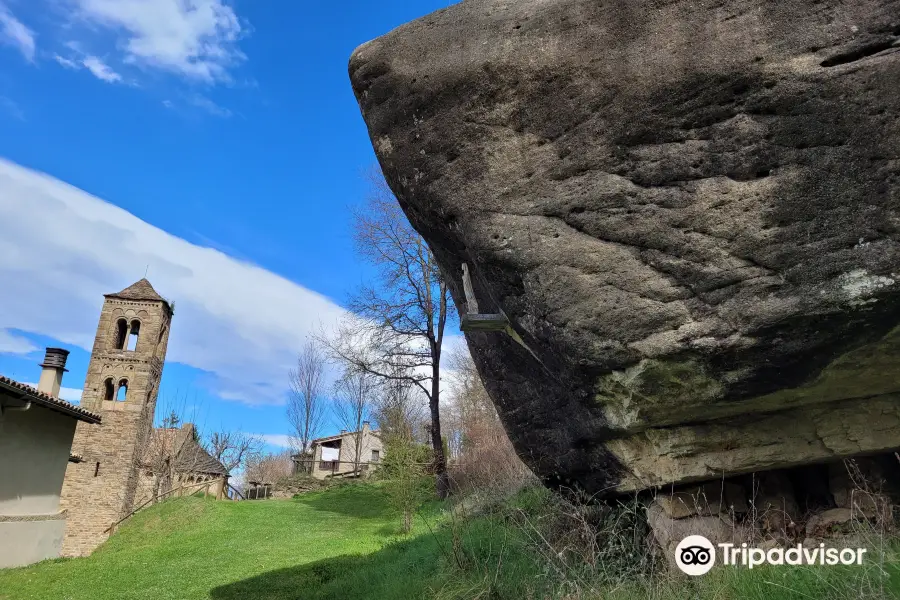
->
0, 404, 77, 568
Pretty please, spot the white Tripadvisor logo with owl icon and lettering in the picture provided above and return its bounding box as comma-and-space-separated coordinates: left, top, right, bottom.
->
675, 535, 866, 576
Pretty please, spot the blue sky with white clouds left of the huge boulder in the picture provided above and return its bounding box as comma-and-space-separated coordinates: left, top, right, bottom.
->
0, 0, 460, 450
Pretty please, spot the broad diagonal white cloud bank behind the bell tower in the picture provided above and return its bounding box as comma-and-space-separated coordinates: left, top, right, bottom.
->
0, 159, 345, 404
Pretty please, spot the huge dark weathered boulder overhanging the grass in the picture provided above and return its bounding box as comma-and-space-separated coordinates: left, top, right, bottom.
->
350, 0, 900, 491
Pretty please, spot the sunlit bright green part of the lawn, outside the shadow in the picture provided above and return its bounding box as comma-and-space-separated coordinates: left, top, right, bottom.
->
0, 486, 446, 600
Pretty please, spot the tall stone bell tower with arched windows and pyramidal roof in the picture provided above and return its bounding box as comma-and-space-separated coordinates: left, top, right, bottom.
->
60, 279, 173, 556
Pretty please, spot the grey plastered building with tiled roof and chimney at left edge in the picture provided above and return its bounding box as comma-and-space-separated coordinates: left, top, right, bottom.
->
0, 348, 101, 568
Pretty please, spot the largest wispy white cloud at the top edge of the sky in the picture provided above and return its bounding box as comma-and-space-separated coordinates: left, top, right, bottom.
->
74, 0, 246, 83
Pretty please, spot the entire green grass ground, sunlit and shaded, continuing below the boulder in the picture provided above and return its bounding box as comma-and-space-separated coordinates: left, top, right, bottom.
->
0, 484, 900, 600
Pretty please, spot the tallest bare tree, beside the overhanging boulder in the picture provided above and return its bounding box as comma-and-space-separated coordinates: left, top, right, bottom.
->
323, 173, 449, 498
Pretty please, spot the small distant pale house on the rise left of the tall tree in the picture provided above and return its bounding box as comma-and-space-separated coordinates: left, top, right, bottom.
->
291, 421, 384, 479
